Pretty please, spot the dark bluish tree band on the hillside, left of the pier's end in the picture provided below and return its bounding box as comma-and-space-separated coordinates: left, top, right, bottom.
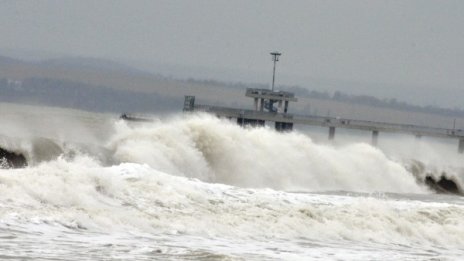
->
0, 78, 182, 112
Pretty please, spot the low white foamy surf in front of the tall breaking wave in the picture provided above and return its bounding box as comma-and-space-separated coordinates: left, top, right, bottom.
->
0, 157, 464, 257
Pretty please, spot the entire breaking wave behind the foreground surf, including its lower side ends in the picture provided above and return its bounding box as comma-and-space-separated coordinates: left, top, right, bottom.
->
0, 112, 463, 194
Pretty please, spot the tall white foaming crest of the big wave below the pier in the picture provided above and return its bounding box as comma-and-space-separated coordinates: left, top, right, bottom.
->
109, 115, 426, 193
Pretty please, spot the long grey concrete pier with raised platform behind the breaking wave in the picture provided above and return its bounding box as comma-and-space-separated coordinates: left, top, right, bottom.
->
178, 89, 464, 153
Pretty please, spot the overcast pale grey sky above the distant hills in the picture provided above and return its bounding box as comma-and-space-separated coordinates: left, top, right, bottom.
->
0, 0, 464, 108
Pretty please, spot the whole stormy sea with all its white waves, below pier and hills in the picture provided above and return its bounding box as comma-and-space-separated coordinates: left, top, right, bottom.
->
0, 103, 464, 260
